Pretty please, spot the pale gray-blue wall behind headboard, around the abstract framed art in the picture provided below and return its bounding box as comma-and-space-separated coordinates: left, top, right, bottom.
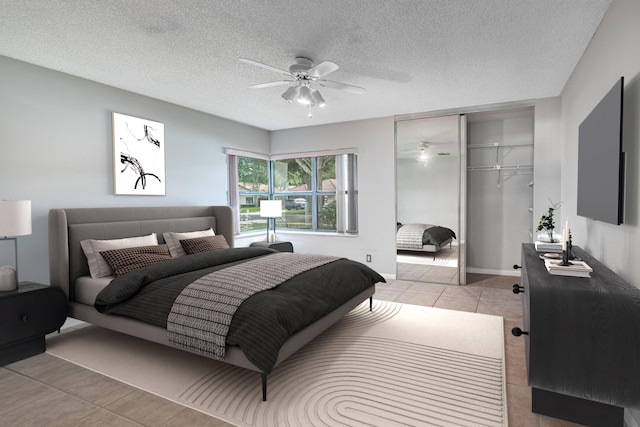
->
0, 57, 269, 283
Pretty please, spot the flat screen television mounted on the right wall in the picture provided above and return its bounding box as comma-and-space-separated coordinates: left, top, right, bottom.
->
577, 77, 625, 225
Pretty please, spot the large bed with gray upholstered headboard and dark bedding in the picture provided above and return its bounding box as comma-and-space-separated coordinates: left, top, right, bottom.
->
49, 206, 384, 400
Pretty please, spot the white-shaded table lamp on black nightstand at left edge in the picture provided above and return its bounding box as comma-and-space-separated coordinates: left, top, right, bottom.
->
0, 200, 31, 291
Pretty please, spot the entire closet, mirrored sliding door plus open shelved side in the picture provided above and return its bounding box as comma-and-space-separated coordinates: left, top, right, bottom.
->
396, 106, 536, 285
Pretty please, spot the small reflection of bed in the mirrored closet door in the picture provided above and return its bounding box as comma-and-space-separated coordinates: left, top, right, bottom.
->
396, 226, 456, 259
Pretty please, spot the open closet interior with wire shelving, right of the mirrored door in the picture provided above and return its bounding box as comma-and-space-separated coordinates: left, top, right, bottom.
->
466, 107, 535, 275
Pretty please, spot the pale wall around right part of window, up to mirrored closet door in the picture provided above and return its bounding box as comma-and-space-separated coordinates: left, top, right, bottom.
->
264, 117, 396, 277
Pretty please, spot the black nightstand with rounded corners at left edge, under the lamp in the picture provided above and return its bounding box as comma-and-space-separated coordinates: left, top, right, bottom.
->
0, 282, 67, 366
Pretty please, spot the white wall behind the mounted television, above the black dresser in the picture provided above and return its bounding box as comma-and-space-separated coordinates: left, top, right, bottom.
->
562, 0, 640, 425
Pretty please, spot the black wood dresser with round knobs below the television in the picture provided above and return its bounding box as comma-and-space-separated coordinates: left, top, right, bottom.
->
513, 244, 640, 427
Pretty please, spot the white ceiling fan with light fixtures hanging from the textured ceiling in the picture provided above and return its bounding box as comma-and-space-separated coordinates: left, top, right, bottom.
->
240, 57, 366, 117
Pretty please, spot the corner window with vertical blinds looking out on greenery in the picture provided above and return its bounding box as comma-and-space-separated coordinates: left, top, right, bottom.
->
227, 150, 358, 234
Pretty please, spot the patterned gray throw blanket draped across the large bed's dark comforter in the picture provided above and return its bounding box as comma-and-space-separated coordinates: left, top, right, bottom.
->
167, 252, 340, 360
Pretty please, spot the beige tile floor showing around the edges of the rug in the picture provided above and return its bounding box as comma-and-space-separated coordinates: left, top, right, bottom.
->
0, 274, 592, 427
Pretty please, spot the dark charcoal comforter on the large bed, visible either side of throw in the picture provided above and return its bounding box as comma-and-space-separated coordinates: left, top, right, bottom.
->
95, 248, 384, 374
